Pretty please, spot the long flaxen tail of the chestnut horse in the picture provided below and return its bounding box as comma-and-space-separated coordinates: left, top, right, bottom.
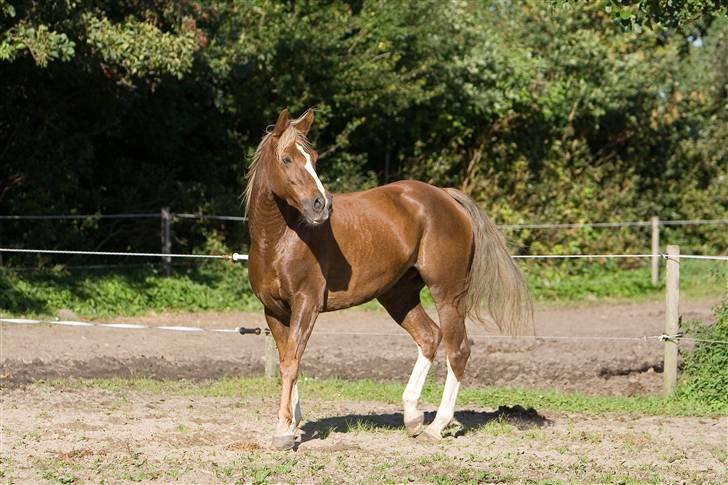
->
445, 188, 534, 335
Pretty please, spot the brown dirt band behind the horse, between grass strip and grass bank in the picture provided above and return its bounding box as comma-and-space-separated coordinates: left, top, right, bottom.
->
0, 300, 717, 395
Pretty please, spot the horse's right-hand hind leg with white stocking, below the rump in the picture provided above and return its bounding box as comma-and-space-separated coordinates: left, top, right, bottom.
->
420, 303, 470, 441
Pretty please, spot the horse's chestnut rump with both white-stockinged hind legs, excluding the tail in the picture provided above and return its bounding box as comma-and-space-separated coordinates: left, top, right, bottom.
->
372, 184, 472, 439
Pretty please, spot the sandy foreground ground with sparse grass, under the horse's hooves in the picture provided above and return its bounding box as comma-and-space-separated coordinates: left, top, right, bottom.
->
0, 384, 728, 484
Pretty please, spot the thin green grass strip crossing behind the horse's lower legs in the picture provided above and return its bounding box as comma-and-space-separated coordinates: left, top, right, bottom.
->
50, 378, 728, 416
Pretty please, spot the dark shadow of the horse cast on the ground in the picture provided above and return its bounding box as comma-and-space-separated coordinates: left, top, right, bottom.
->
301, 405, 552, 443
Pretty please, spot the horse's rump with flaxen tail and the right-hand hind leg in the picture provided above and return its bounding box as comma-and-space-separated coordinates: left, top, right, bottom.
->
418, 185, 532, 439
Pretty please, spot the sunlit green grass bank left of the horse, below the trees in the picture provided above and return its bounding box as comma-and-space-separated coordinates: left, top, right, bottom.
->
0, 264, 259, 318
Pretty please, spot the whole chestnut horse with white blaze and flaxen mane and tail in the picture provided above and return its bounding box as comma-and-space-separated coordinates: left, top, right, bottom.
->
244, 110, 532, 449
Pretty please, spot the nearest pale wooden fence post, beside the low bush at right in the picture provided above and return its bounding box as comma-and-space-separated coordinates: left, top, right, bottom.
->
662, 245, 680, 396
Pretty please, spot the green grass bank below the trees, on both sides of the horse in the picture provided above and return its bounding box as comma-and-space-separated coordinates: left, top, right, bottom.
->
0, 260, 728, 318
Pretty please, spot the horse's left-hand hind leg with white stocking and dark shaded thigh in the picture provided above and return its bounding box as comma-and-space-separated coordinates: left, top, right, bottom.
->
379, 276, 441, 436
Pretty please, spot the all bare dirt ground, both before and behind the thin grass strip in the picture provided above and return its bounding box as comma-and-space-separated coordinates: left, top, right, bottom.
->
0, 300, 728, 484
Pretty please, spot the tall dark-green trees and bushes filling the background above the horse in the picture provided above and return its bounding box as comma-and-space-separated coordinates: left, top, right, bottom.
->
0, 0, 728, 265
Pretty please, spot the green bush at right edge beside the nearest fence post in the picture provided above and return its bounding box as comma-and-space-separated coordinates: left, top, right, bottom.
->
678, 301, 728, 407
